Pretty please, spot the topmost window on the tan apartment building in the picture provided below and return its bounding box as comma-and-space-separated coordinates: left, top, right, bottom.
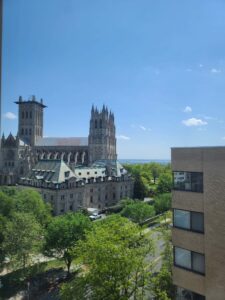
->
173, 172, 203, 193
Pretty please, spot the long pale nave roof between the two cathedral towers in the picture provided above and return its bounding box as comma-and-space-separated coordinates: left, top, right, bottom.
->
35, 137, 88, 146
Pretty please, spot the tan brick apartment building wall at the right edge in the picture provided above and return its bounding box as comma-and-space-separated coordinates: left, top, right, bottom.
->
172, 147, 225, 300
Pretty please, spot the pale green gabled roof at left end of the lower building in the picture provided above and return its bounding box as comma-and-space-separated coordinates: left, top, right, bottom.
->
25, 160, 75, 183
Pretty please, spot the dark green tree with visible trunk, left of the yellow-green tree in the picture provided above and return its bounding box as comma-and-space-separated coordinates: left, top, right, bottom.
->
44, 213, 91, 274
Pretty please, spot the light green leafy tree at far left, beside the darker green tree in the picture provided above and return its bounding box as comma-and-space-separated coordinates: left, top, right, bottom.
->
2, 213, 43, 268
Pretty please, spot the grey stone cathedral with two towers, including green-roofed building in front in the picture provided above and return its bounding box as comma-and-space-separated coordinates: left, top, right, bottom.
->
0, 96, 133, 215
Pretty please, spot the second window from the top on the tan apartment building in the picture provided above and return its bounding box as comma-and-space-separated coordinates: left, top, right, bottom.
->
173, 209, 204, 233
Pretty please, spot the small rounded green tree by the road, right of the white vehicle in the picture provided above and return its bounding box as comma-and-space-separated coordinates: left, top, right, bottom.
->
121, 201, 155, 224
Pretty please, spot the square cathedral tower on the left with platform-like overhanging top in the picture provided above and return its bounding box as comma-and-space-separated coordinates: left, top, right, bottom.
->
15, 96, 46, 146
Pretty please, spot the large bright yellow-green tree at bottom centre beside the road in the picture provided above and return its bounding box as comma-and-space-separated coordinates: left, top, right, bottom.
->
61, 215, 153, 300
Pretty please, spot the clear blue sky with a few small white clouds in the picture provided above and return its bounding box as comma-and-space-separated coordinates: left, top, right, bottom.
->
2, 0, 225, 159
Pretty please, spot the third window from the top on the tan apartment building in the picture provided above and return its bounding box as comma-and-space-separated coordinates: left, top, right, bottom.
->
174, 247, 205, 274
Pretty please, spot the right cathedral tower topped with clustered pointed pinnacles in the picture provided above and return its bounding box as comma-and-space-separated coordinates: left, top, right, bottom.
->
88, 105, 117, 163
